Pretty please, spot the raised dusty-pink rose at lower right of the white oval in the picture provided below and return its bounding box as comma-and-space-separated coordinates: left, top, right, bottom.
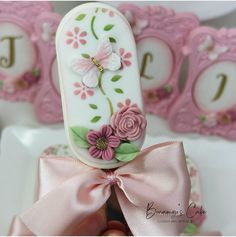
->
111, 105, 147, 141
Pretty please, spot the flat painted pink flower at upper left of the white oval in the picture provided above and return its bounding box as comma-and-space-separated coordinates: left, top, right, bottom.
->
66, 27, 87, 49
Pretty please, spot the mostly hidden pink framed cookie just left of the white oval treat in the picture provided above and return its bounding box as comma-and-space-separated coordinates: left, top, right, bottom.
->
34, 12, 63, 123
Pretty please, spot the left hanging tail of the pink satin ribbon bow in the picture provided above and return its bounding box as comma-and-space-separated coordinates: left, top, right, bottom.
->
10, 170, 110, 236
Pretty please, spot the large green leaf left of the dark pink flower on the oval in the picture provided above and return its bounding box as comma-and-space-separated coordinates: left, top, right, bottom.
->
70, 126, 89, 148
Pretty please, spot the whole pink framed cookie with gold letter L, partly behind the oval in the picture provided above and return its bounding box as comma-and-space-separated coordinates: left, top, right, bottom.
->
119, 3, 199, 118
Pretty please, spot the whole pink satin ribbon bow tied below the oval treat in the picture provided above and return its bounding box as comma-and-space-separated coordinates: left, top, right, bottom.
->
10, 142, 190, 235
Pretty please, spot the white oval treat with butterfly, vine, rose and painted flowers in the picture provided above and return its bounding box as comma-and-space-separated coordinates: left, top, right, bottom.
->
56, 3, 146, 169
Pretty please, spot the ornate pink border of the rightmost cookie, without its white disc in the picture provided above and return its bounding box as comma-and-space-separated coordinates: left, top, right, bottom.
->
168, 27, 236, 140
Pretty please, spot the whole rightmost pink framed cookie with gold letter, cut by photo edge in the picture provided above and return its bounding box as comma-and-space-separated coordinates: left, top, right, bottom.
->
169, 27, 236, 140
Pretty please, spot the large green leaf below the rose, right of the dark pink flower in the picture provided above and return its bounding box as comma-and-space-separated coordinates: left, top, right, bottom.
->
115, 143, 139, 162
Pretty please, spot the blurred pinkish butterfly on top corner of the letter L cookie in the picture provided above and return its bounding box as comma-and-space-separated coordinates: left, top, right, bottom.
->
124, 10, 148, 35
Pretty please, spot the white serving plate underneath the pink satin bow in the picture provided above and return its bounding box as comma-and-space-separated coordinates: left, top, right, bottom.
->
0, 115, 236, 235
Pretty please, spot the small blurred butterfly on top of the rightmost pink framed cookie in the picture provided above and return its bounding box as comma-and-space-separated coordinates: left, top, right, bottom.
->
198, 35, 228, 61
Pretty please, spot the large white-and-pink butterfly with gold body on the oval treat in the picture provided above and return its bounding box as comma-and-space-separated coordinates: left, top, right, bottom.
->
72, 38, 121, 88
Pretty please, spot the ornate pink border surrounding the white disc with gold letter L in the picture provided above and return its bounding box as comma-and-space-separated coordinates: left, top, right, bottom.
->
119, 4, 199, 118
